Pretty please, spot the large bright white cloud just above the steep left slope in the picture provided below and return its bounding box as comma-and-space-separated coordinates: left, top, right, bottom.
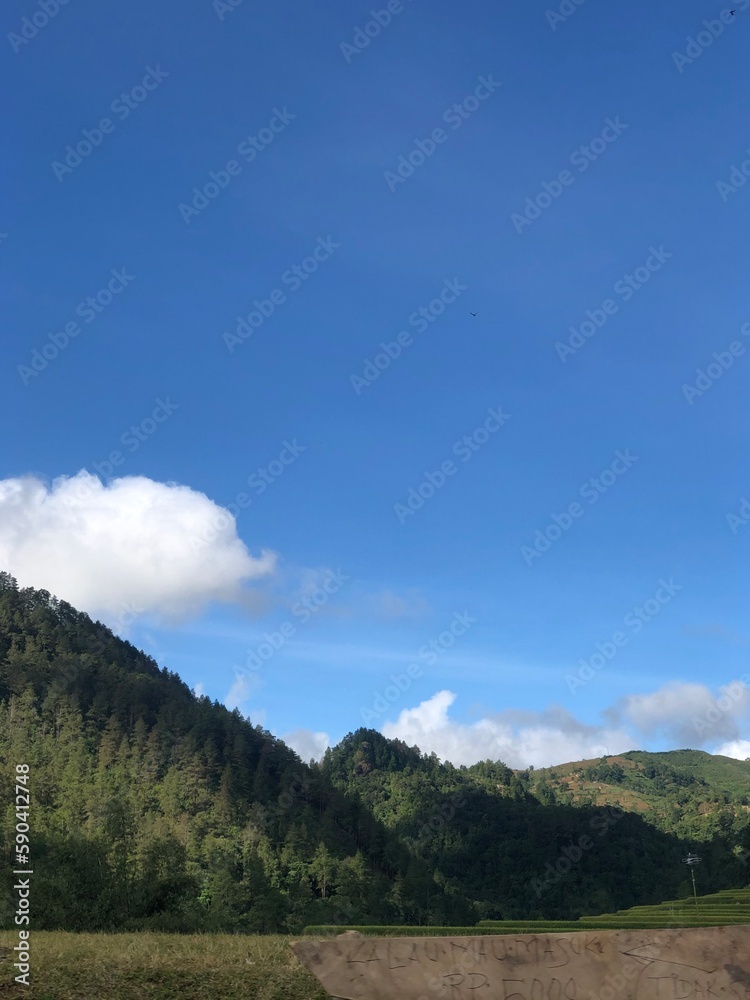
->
0, 469, 276, 623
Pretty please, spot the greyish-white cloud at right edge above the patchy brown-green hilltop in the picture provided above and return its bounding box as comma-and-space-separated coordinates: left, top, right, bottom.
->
608, 680, 750, 747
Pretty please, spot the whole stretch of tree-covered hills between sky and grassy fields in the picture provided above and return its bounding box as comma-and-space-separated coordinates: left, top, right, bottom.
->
0, 574, 750, 932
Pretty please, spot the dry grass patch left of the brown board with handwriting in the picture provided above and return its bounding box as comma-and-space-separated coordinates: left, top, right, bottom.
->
0, 931, 330, 1000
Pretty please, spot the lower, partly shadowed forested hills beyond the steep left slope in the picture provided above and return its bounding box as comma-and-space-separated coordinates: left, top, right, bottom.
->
322, 730, 750, 918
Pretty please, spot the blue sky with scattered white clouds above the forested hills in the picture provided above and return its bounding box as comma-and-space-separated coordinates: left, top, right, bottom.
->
0, 0, 750, 766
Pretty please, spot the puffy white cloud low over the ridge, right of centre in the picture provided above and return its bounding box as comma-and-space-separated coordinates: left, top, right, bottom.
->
382, 691, 633, 768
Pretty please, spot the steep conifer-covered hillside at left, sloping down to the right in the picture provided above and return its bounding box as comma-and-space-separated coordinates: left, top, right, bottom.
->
0, 576, 456, 932
